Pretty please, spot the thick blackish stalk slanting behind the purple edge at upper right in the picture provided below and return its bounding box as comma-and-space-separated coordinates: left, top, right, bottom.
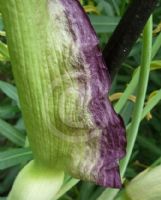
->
103, 0, 159, 79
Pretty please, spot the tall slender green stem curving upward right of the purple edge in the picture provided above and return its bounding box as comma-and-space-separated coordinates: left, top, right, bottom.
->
97, 17, 152, 200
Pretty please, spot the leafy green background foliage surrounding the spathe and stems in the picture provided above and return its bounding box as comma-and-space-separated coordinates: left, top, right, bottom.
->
0, 0, 161, 200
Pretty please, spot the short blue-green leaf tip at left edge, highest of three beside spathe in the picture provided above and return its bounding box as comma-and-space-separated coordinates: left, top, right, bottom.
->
0, 81, 19, 105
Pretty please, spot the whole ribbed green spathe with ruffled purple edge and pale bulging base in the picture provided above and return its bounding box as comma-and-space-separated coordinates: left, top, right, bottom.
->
0, 0, 126, 200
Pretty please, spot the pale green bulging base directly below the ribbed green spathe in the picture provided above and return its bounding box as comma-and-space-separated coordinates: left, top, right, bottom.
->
8, 161, 64, 200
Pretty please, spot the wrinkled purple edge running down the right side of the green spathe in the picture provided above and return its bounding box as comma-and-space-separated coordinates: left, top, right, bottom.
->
61, 0, 126, 188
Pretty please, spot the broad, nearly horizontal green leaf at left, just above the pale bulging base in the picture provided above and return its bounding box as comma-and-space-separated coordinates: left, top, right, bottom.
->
0, 148, 32, 170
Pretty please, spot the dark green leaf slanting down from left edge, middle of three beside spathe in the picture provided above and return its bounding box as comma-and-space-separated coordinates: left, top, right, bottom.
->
0, 119, 25, 146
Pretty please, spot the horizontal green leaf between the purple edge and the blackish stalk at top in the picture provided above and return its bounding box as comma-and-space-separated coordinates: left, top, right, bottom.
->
89, 15, 120, 33
